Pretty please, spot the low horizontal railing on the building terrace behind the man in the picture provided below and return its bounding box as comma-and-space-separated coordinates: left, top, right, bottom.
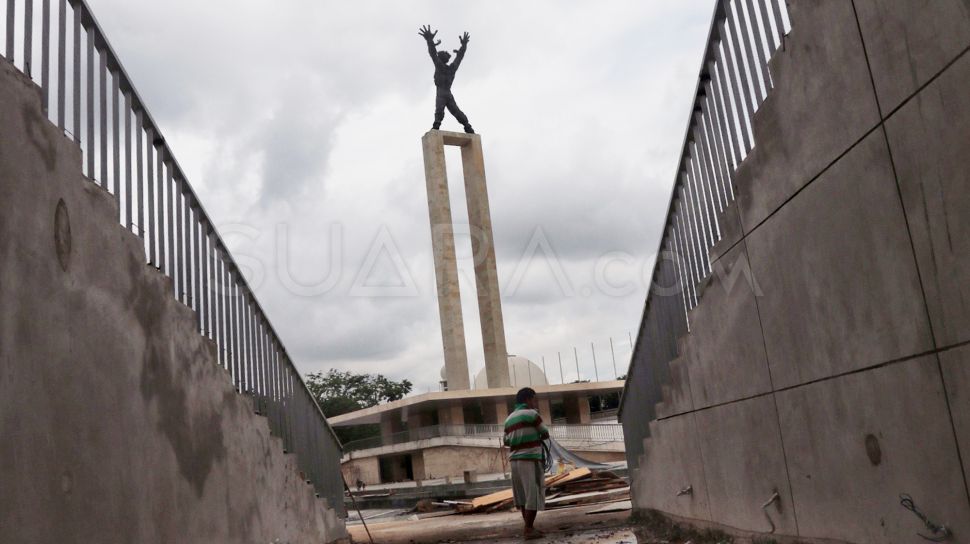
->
344, 424, 623, 452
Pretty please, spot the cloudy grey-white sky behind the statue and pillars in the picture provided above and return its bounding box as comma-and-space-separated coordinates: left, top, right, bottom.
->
89, 0, 713, 392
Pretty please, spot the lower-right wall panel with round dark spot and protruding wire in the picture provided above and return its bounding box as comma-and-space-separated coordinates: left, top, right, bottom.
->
778, 355, 970, 544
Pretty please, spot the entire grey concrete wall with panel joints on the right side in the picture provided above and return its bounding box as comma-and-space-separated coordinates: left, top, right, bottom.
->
624, 0, 970, 544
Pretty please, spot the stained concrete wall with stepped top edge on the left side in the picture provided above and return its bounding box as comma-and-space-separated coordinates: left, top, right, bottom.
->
0, 60, 346, 544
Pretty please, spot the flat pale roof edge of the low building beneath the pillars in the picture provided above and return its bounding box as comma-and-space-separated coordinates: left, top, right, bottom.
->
327, 380, 624, 427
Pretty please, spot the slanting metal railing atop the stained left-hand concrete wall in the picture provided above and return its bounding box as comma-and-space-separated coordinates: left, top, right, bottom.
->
0, 0, 343, 512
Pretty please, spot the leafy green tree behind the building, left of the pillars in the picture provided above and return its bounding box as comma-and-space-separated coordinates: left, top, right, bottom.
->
306, 369, 412, 443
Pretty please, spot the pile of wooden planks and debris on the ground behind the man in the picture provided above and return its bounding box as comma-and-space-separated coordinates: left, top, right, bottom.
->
447, 468, 630, 514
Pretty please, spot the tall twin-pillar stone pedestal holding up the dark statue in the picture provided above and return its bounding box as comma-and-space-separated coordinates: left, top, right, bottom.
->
421, 130, 511, 390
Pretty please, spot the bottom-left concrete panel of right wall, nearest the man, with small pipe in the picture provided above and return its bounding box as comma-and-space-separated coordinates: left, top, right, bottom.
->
631, 414, 711, 521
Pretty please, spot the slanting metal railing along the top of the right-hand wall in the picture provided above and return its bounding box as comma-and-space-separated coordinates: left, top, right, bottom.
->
620, 0, 790, 466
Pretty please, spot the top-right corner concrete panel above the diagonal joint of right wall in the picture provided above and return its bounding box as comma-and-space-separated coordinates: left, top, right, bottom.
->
854, 0, 970, 115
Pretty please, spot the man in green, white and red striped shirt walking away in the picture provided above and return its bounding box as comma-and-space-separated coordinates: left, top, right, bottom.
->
504, 387, 549, 540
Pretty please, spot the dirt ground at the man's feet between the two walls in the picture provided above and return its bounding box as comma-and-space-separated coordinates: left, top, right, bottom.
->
348, 503, 756, 544
